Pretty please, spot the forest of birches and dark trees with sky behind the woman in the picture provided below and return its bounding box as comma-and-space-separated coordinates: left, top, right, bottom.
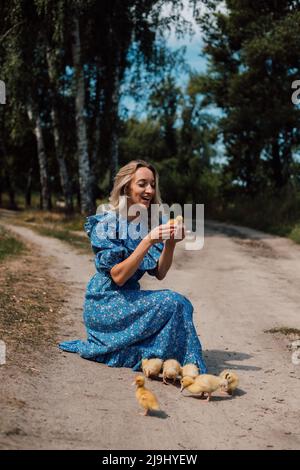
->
0, 0, 300, 242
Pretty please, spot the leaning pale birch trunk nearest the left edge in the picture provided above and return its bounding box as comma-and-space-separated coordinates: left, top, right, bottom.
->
27, 105, 51, 210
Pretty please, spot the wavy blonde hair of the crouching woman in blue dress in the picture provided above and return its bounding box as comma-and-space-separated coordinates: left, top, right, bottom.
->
109, 160, 161, 212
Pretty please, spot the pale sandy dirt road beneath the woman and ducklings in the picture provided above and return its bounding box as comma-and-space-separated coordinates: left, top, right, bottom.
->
0, 218, 300, 450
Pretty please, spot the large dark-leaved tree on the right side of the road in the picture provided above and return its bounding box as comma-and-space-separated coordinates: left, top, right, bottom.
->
199, 0, 300, 194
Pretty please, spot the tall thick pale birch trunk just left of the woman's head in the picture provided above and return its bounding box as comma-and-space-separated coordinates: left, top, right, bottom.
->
72, 18, 95, 214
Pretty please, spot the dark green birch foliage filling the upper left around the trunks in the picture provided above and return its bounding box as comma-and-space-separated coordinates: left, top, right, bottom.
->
0, 0, 197, 207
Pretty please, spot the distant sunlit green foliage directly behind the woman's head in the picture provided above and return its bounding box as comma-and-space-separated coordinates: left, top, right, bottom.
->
120, 65, 221, 204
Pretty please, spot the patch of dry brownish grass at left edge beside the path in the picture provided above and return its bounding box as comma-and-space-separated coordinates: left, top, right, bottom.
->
0, 239, 65, 365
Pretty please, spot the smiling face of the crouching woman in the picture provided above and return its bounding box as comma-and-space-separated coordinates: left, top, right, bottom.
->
128, 167, 155, 209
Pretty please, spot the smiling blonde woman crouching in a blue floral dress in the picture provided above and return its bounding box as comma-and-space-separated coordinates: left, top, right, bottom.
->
59, 160, 206, 373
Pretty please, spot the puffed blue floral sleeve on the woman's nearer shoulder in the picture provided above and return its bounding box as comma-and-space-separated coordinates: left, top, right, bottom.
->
85, 215, 129, 271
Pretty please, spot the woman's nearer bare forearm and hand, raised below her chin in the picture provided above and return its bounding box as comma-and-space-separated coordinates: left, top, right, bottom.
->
110, 225, 174, 287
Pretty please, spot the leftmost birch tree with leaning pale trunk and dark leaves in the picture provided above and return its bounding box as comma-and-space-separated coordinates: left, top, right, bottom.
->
2, 0, 51, 209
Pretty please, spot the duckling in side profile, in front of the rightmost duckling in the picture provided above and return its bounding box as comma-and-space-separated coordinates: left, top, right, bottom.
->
180, 374, 228, 401
